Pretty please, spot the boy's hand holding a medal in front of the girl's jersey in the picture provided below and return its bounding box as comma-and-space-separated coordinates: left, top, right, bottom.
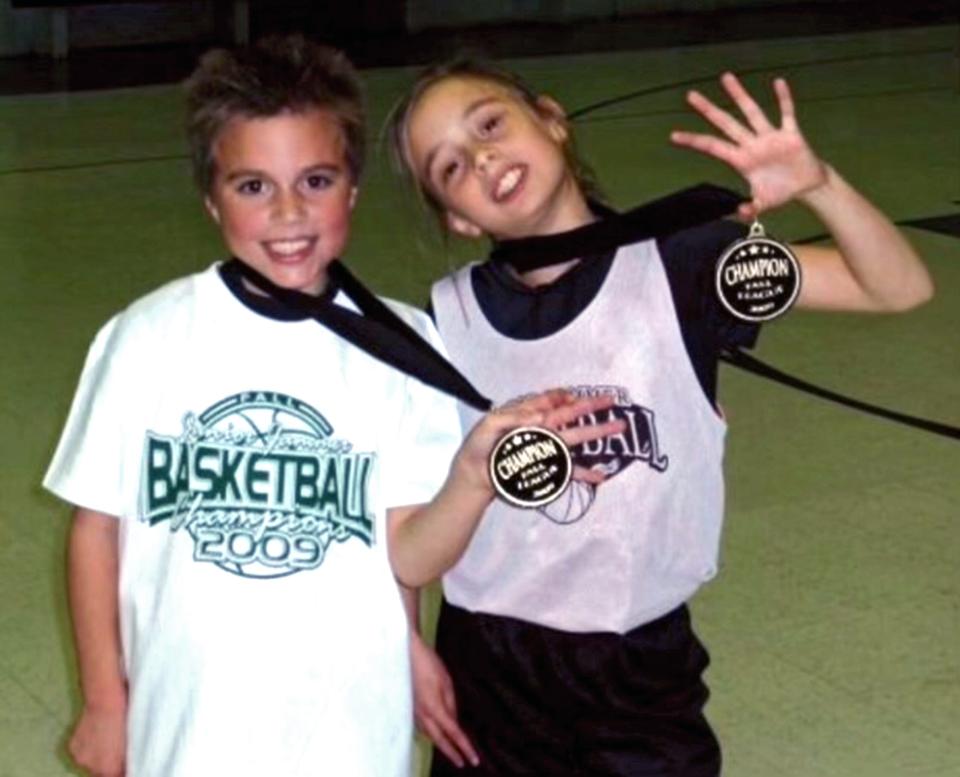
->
454, 389, 626, 497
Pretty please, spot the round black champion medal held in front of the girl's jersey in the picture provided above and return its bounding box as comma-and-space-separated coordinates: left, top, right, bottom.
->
490, 426, 573, 508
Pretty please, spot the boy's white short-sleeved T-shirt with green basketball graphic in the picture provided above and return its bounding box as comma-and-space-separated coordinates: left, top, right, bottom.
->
45, 267, 459, 777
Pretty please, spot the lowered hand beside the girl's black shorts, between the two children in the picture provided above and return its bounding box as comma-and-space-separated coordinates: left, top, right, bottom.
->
410, 635, 480, 768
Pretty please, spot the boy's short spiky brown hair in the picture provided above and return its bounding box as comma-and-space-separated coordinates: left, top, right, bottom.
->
186, 35, 366, 193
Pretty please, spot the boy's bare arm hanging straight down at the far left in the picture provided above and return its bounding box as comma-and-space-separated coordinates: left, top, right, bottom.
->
67, 508, 127, 777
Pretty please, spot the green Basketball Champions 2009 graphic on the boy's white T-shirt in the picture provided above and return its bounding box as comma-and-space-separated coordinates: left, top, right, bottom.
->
142, 391, 374, 578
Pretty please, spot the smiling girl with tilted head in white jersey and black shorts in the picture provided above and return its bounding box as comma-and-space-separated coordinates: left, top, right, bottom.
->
391, 57, 932, 777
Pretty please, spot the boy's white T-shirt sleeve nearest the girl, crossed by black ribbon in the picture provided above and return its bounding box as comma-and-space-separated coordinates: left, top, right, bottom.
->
376, 309, 461, 508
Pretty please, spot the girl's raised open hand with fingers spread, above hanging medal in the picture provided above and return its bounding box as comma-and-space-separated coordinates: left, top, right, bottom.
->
670, 73, 827, 219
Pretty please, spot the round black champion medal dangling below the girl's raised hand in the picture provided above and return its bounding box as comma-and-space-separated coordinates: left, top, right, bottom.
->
716, 221, 801, 321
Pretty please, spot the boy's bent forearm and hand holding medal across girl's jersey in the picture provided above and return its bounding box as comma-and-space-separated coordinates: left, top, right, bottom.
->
387, 391, 624, 588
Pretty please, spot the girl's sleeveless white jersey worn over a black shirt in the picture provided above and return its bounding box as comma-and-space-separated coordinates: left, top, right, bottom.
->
433, 241, 726, 633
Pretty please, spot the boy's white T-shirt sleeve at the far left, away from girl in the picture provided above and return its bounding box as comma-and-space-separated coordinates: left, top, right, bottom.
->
43, 317, 135, 517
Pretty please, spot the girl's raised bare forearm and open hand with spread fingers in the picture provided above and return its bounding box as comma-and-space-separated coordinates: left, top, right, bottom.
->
671, 73, 933, 312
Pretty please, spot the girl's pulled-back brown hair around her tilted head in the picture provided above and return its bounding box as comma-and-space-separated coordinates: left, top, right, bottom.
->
387, 56, 603, 227
